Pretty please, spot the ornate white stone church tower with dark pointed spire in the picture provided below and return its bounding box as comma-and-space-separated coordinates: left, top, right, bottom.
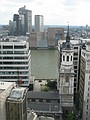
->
58, 26, 74, 112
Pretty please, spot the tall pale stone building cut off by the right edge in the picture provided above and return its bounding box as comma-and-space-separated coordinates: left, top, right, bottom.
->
79, 41, 90, 120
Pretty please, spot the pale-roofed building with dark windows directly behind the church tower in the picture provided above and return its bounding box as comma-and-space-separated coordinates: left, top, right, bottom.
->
58, 39, 83, 107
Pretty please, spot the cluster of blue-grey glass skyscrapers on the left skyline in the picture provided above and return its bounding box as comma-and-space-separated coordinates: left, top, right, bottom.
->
9, 6, 32, 36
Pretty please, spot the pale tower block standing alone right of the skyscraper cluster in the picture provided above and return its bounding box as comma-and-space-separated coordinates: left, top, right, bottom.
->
35, 15, 44, 32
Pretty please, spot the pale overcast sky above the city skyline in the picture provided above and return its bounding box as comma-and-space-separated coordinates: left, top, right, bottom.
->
0, 0, 90, 26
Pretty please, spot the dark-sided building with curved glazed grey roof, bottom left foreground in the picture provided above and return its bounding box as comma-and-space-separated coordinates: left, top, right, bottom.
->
6, 87, 27, 120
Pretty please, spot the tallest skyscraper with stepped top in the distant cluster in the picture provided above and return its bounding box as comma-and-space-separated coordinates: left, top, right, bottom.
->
18, 6, 32, 35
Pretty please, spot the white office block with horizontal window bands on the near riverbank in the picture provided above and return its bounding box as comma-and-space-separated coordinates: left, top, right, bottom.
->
0, 36, 32, 86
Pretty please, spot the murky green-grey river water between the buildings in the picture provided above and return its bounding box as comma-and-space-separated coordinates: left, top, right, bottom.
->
31, 50, 58, 79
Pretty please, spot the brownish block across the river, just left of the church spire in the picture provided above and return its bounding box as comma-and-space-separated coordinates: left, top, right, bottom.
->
47, 28, 64, 47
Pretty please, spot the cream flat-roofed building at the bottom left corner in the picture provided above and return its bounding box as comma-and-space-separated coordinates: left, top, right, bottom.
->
0, 82, 16, 120
